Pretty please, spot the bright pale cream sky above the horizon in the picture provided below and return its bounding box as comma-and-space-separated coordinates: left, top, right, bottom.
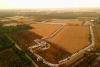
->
0, 0, 100, 9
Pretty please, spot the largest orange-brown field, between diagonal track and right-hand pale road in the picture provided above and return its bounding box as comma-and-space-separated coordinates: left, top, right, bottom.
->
48, 26, 89, 54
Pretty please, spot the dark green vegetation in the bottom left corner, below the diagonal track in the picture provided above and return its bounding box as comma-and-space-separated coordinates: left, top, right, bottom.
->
0, 48, 34, 67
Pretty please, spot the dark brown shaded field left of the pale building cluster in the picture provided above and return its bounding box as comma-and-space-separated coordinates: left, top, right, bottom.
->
10, 31, 42, 48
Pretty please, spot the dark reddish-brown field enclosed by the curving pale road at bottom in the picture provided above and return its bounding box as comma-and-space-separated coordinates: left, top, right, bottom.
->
35, 42, 71, 64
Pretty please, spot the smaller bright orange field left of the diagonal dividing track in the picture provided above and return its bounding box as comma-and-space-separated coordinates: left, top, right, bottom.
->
29, 24, 62, 37
